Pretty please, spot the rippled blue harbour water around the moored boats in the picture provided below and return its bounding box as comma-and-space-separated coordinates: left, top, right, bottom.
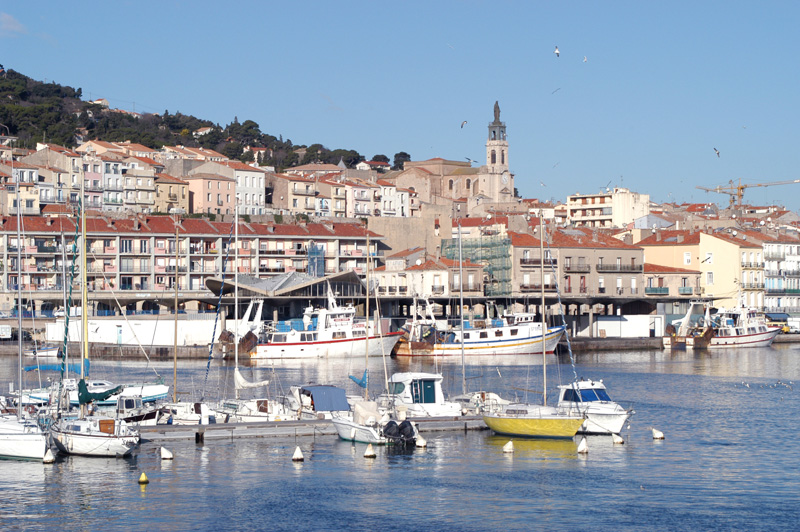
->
0, 345, 800, 530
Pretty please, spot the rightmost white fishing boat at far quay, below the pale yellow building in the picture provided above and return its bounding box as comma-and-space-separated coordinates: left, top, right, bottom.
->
663, 301, 781, 349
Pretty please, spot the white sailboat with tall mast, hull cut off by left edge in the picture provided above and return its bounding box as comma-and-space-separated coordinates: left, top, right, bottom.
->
0, 137, 49, 460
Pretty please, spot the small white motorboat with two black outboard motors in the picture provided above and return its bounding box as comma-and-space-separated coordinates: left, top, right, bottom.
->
331, 401, 419, 446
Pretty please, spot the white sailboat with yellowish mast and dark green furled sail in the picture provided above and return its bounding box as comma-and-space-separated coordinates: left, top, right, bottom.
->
50, 169, 139, 457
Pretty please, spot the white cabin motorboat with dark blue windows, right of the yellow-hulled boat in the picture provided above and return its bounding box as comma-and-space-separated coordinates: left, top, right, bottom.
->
558, 379, 634, 434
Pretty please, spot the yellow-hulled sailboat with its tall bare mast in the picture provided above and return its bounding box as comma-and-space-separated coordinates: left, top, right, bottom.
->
483, 214, 585, 438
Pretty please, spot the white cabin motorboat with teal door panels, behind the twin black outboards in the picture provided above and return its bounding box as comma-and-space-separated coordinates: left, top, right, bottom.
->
377, 372, 463, 417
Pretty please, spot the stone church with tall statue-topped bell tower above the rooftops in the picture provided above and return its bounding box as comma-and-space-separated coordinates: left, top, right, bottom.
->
387, 102, 517, 212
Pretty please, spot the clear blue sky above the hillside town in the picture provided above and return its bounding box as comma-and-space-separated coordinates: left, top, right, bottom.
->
0, 0, 800, 211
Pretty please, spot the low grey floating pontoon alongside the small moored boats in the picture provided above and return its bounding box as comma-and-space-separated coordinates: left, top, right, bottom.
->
139, 415, 488, 443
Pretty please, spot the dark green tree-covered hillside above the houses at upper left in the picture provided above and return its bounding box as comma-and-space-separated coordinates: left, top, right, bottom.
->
0, 70, 394, 171
